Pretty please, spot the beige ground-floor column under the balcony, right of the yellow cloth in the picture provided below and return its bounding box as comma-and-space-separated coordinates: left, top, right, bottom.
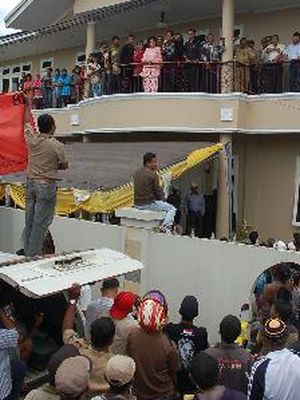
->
216, 134, 232, 239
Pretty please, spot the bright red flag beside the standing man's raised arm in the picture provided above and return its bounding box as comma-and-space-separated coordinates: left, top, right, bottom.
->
0, 93, 28, 175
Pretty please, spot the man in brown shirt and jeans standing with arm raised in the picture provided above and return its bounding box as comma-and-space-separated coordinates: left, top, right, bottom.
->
24, 98, 68, 257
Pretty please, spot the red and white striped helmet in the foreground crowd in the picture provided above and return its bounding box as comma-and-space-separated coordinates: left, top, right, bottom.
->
137, 298, 168, 334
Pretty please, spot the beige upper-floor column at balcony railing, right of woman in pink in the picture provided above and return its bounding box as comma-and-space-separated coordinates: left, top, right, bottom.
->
221, 0, 234, 93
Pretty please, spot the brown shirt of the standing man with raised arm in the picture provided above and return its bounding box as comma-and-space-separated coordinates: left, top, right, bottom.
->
25, 124, 67, 181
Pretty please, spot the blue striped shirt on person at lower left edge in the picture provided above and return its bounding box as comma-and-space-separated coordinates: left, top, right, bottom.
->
0, 329, 19, 400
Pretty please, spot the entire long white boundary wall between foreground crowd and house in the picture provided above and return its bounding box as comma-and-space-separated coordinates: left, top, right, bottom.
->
0, 207, 300, 343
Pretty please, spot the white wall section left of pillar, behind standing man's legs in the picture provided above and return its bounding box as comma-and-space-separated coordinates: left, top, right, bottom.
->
0, 207, 125, 252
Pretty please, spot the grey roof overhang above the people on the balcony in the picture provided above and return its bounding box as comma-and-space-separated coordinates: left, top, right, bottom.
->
0, 0, 300, 61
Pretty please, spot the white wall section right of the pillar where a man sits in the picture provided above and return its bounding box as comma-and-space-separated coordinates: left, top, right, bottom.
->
145, 234, 300, 342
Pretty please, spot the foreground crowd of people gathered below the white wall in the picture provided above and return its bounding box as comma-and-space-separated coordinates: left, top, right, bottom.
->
0, 263, 300, 400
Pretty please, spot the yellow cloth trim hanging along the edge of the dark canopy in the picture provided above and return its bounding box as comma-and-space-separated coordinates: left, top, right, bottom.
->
0, 144, 223, 216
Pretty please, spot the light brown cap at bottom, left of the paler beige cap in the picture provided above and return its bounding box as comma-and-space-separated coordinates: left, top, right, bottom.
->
55, 356, 91, 397
